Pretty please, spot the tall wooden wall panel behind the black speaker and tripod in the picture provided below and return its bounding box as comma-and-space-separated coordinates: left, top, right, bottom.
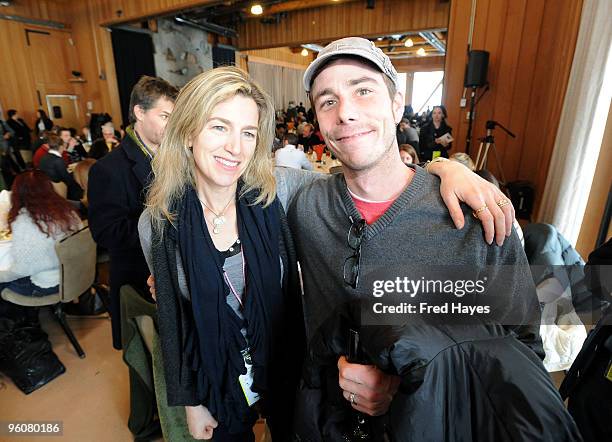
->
443, 0, 582, 214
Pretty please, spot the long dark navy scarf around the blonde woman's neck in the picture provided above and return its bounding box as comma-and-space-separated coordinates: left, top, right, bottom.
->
177, 185, 282, 433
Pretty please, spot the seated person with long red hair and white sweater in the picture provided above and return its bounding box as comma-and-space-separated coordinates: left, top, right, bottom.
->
0, 170, 83, 296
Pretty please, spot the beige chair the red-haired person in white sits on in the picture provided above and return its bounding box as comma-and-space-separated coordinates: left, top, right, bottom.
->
1, 227, 96, 358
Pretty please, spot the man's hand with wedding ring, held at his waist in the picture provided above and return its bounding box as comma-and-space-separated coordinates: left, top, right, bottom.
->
338, 356, 400, 416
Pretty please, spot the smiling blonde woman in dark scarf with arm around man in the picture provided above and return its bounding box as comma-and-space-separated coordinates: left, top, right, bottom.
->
139, 67, 516, 441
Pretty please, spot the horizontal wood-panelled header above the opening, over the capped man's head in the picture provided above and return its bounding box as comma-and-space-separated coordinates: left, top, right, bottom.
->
238, 0, 449, 50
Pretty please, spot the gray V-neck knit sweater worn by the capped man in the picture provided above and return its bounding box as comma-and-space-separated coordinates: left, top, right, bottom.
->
287, 167, 541, 353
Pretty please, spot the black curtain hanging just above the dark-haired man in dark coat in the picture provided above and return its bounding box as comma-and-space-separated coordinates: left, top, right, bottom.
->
111, 29, 155, 128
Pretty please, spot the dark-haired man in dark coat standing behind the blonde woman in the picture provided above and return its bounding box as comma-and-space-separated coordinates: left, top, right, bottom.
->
88, 76, 178, 349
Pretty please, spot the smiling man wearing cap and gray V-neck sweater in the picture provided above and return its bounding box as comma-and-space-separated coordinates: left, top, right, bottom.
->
287, 37, 580, 441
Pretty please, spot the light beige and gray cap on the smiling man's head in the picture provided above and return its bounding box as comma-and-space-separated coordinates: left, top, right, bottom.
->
304, 37, 399, 92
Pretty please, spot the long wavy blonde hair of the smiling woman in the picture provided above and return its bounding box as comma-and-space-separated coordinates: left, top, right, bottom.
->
146, 66, 276, 231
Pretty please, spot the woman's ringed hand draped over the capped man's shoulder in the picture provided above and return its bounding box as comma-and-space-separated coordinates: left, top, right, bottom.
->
427, 161, 514, 246
